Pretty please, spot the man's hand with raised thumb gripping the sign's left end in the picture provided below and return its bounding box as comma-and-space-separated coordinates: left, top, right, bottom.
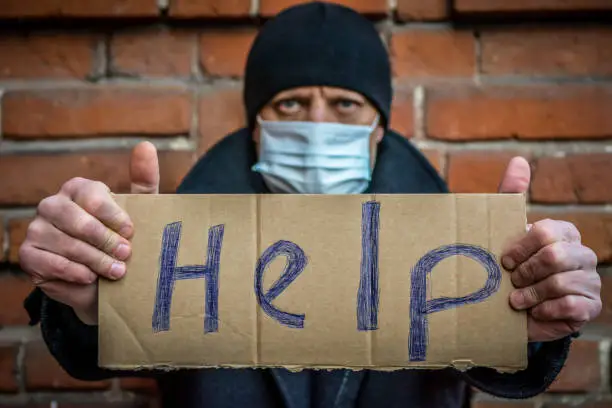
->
19, 142, 159, 324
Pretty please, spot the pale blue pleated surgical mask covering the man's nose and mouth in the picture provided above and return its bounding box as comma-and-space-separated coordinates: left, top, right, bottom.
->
253, 117, 378, 194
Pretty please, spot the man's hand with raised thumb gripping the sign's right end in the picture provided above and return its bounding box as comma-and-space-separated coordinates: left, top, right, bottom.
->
499, 157, 601, 342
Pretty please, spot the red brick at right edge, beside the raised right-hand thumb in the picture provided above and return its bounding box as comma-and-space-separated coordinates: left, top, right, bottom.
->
531, 153, 612, 204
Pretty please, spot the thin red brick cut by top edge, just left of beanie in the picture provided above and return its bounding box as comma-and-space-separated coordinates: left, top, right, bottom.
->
170, 0, 251, 18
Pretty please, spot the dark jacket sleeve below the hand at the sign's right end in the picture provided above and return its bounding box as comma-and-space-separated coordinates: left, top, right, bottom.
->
463, 334, 578, 399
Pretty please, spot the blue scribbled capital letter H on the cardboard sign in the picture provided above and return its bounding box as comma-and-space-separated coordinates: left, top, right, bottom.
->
152, 222, 224, 333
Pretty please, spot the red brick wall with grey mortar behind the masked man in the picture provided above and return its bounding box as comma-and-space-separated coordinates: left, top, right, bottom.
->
0, 0, 612, 408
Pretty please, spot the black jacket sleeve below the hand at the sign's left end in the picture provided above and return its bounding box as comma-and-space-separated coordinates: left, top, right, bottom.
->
24, 288, 158, 381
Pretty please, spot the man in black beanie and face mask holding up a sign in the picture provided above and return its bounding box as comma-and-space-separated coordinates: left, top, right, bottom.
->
20, 3, 601, 408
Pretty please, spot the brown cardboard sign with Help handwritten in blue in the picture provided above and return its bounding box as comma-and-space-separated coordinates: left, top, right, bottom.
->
99, 194, 527, 371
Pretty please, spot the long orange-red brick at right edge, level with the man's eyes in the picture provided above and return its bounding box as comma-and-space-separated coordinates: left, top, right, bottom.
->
426, 85, 612, 141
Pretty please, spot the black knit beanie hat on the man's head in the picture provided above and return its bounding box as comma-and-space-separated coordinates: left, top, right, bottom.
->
244, 2, 392, 129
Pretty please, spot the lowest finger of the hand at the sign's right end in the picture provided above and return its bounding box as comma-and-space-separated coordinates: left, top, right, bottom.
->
531, 295, 601, 323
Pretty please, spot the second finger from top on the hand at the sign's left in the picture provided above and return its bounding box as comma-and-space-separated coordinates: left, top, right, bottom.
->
38, 195, 130, 259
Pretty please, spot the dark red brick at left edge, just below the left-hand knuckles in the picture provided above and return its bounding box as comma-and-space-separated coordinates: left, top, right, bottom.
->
0, 273, 34, 326
